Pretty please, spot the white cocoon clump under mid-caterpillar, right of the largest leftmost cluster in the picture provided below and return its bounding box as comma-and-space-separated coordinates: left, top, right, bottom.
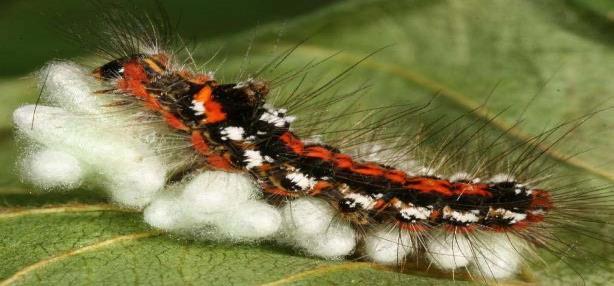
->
145, 171, 281, 241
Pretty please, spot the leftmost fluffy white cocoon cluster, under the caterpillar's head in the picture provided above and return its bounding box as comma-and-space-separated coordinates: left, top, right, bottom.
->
13, 62, 167, 208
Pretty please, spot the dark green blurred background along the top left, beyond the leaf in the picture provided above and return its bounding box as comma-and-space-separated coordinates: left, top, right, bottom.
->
0, 0, 336, 77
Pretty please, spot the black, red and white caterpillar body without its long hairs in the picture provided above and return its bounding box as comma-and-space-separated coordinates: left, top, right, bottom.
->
94, 54, 552, 235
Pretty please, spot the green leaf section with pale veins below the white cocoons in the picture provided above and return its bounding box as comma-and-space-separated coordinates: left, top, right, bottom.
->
0, 196, 462, 285
